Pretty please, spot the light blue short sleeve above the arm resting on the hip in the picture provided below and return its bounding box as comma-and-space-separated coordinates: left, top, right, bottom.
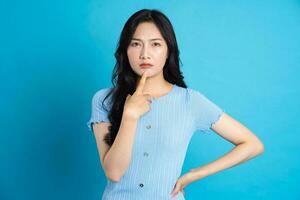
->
190, 90, 225, 132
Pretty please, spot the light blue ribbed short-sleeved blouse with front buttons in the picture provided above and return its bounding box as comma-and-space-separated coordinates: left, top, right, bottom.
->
87, 85, 225, 200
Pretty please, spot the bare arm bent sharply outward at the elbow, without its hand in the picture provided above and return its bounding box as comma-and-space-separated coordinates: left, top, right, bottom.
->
189, 113, 264, 182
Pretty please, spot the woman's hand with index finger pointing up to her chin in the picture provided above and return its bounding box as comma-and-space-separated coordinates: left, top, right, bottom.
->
124, 70, 151, 119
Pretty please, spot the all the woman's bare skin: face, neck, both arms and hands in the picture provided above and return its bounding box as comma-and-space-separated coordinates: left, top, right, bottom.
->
94, 22, 264, 197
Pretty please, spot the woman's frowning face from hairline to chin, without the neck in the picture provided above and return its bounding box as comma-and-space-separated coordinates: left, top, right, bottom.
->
127, 22, 168, 77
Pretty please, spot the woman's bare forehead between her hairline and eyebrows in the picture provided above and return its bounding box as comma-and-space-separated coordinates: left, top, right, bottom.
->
133, 22, 163, 40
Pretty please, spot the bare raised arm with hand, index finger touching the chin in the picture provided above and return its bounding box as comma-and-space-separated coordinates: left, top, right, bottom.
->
95, 71, 151, 182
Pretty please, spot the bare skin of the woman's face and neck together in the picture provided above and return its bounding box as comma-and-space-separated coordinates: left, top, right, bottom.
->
127, 22, 173, 98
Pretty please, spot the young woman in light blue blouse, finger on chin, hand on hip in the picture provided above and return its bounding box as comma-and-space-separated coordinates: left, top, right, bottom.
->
87, 9, 264, 200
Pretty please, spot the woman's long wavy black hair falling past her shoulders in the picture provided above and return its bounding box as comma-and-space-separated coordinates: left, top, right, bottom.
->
102, 9, 187, 146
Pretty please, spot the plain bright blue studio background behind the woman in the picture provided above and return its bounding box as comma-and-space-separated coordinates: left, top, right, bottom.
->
0, 0, 300, 200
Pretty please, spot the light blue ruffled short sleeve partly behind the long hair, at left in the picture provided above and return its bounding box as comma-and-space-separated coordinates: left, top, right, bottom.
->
87, 88, 111, 131
